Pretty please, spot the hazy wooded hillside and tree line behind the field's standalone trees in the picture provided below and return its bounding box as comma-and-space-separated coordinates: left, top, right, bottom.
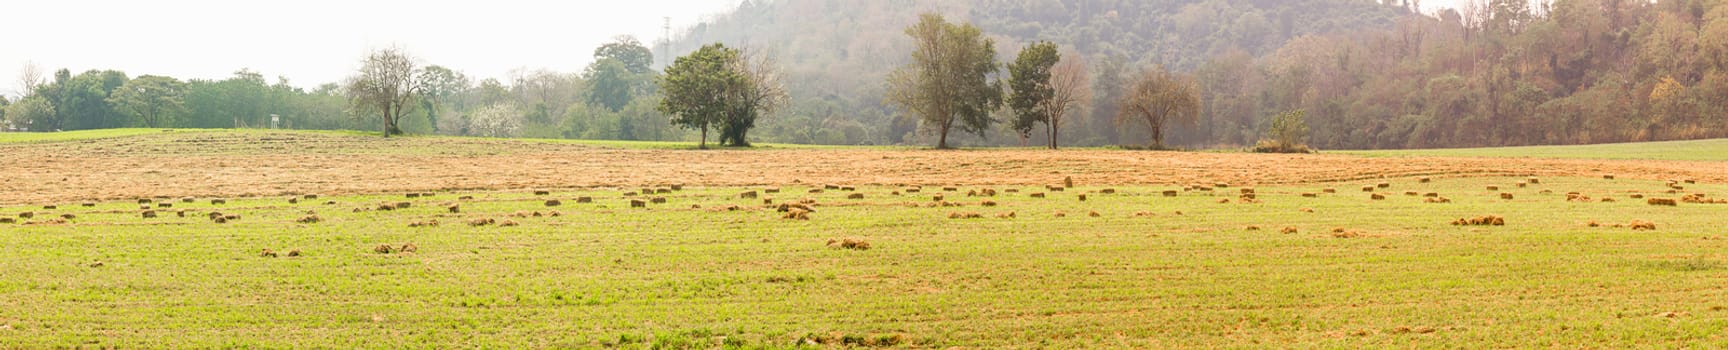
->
0, 0, 1728, 150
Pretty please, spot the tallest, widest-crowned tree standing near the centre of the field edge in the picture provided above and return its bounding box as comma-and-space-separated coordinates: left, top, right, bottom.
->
888, 14, 1002, 148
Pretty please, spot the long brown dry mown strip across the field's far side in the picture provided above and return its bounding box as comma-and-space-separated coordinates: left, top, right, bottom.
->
0, 131, 1728, 203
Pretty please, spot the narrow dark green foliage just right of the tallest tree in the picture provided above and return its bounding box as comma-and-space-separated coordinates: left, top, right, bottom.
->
1007, 41, 1063, 138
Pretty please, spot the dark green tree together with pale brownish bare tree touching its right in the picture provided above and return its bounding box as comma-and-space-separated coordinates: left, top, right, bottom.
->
1007, 41, 1092, 150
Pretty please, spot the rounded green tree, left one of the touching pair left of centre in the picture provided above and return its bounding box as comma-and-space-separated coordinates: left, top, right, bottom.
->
657, 43, 745, 148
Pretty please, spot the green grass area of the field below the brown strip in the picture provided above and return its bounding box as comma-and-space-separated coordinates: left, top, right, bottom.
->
0, 130, 1728, 348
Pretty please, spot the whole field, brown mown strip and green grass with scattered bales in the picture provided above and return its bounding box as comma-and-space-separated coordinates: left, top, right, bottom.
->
0, 131, 1728, 348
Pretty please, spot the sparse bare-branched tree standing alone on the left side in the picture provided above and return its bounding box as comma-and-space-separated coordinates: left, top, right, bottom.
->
347, 48, 420, 138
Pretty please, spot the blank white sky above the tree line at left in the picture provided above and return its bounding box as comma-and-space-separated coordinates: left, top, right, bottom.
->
0, 0, 738, 95
